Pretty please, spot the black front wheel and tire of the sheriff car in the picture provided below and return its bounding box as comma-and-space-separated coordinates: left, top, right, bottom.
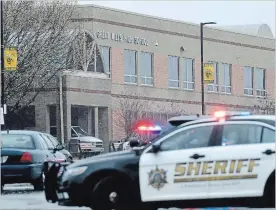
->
91, 177, 140, 210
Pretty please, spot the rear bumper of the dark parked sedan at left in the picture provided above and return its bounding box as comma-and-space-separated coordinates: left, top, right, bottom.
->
1, 164, 43, 184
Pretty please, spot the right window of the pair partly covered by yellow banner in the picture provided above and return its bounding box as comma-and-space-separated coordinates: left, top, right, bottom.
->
219, 63, 232, 94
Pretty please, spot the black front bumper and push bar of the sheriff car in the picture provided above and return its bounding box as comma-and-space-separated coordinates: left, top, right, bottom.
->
44, 164, 89, 206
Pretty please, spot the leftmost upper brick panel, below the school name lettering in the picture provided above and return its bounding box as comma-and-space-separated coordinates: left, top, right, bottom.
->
111, 48, 124, 84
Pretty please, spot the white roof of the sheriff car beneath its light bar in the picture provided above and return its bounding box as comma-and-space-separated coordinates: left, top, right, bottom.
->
180, 115, 276, 127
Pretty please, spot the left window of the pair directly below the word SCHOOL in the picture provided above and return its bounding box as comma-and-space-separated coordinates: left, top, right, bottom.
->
124, 50, 137, 84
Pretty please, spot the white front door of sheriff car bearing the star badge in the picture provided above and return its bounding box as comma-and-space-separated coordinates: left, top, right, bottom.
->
139, 123, 219, 202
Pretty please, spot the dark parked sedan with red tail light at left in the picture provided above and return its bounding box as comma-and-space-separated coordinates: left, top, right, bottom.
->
1, 130, 66, 190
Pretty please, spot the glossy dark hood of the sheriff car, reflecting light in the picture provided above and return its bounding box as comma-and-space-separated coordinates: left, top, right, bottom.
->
67, 150, 137, 168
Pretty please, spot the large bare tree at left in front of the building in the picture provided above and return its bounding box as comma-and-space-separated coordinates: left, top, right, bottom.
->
3, 0, 76, 112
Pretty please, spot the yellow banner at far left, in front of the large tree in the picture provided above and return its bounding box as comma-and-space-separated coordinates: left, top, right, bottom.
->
4, 47, 17, 71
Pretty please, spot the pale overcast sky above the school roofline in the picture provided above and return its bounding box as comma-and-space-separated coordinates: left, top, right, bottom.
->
79, 0, 276, 35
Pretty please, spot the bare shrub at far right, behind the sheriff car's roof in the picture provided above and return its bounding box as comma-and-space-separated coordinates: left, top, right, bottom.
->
253, 97, 275, 115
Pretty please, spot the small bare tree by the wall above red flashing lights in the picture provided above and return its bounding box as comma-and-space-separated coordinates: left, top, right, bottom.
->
114, 98, 149, 138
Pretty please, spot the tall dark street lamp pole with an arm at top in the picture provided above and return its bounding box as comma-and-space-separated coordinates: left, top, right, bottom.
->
200, 22, 217, 115
